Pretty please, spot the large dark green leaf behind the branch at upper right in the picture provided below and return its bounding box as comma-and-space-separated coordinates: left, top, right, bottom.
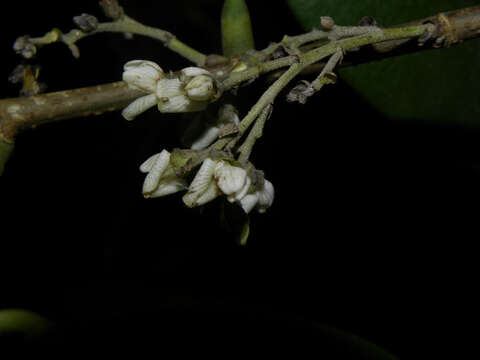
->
288, 0, 480, 125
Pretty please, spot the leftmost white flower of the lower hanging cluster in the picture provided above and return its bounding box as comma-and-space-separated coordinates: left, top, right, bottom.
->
140, 150, 187, 198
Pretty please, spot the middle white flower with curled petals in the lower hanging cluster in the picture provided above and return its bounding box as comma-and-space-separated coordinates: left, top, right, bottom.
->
183, 158, 251, 207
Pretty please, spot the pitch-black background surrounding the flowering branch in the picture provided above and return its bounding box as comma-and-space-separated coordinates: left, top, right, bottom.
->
0, 0, 480, 358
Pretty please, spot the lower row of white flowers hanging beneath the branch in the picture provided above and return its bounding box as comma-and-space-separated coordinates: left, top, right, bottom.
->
140, 150, 275, 213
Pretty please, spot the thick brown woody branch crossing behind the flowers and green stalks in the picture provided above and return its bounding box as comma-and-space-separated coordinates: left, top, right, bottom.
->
0, 6, 480, 143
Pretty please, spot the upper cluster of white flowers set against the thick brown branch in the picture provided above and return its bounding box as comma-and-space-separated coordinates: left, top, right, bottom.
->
122, 60, 216, 120
